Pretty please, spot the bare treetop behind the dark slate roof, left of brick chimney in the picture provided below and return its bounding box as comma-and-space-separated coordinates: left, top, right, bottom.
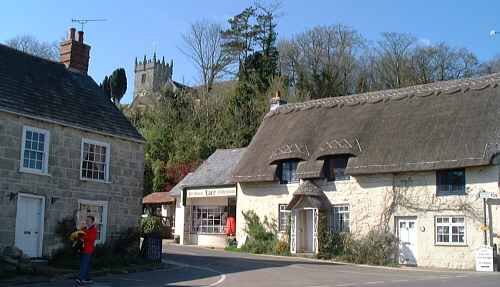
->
5, 35, 59, 61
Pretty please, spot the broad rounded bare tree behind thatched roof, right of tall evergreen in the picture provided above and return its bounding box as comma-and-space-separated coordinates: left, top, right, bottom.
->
279, 24, 365, 99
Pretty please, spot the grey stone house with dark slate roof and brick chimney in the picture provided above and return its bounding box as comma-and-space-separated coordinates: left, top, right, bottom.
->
0, 28, 144, 257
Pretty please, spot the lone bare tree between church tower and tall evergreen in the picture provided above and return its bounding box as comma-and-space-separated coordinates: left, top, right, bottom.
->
181, 20, 233, 93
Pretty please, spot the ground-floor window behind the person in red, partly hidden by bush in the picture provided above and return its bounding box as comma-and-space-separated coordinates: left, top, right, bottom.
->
77, 200, 108, 244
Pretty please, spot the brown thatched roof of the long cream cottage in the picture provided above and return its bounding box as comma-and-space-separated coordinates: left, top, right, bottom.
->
233, 74, 500, 182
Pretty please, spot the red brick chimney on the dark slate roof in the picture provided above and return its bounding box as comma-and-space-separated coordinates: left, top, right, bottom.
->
59, 28, 90, 75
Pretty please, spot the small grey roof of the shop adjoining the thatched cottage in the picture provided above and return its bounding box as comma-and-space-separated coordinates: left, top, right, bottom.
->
174, 148, 246, 189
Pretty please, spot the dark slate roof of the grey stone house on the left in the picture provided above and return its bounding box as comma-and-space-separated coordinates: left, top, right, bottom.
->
0, 44, 144, 141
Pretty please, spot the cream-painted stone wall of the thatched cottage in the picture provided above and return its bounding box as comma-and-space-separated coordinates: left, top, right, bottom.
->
236, 166, 500, 269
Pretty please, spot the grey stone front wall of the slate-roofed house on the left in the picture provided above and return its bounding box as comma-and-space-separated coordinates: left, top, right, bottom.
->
0, 112, 144, 256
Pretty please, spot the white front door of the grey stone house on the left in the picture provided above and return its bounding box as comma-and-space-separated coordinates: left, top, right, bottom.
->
15, 194, 44, 257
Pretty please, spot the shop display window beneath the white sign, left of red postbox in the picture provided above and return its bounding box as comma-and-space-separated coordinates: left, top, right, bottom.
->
192, 206, 227, 234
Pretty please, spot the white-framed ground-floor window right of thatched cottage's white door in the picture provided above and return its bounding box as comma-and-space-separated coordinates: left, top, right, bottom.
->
436, 216, 465, 244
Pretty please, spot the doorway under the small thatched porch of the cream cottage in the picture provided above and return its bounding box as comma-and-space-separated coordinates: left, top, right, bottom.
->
297, 209, 314, 253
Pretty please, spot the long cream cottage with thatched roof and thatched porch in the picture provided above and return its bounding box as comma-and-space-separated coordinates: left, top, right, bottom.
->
233, 74, 500, 269
